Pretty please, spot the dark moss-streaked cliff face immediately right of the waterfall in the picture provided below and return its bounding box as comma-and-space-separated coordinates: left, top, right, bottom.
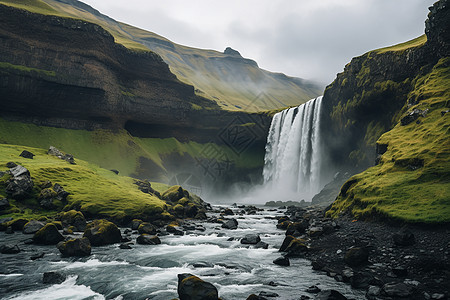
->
322, 1, 450, 171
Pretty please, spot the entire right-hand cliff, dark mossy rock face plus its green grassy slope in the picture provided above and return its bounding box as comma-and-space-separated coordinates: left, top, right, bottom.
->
324, 1, 450, 223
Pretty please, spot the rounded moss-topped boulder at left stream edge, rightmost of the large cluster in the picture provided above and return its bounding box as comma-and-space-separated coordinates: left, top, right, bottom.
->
83, 219, 122, 246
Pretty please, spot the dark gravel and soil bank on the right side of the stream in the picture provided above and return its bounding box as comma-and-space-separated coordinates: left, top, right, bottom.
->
278, 208, 450, 299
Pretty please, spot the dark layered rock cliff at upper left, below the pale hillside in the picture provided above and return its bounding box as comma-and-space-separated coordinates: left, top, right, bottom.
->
0, 5, 244, 134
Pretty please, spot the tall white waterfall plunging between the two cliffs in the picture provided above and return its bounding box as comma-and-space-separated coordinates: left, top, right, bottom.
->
263, 97, 322, 201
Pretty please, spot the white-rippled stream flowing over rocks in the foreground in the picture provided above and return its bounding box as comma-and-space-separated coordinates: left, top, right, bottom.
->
0, 208, 363, 300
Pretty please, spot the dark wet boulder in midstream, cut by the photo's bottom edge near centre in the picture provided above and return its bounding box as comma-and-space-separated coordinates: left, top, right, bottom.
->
178, 273, 219, 300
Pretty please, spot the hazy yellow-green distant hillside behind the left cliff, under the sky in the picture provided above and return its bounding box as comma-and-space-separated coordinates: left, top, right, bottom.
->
0, 0, 321, 112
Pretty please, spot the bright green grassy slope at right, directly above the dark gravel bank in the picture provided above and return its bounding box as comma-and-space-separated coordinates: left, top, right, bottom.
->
328, 57, 450, 223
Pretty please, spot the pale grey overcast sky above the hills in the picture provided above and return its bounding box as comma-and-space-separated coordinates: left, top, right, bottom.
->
83, 0, 435, 84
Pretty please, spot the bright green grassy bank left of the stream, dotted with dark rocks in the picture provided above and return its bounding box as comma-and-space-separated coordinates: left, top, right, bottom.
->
0, 144, 167, 222
